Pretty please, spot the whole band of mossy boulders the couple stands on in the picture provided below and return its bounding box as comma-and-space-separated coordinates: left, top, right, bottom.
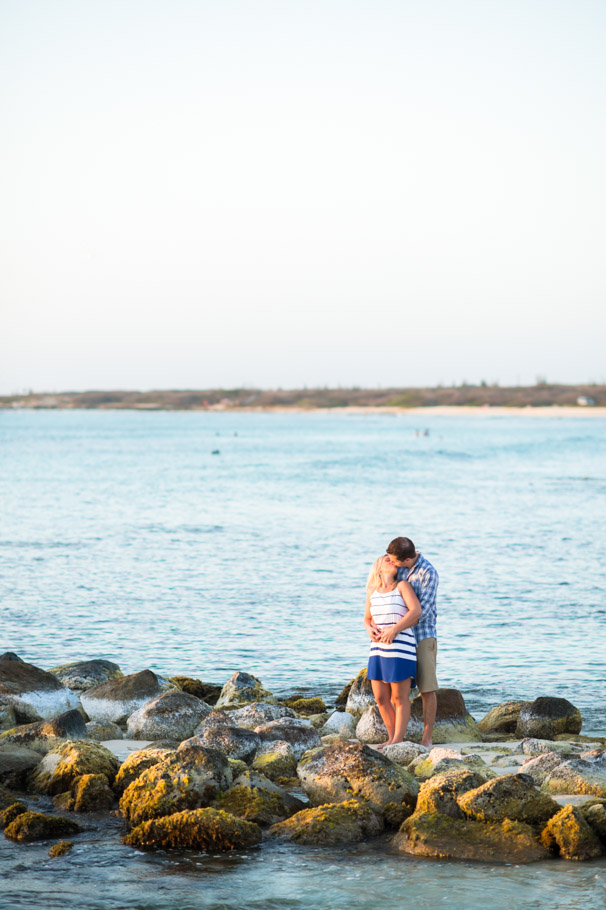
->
0, 652, 606, 863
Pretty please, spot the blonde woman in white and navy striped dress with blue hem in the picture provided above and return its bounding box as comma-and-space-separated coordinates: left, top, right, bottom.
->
364, 555, 421, 748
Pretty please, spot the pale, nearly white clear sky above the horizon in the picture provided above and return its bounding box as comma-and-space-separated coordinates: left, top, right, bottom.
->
0, 0, 606, 394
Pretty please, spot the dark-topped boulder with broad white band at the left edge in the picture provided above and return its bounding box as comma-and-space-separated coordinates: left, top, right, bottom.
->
0, 659, 80, 724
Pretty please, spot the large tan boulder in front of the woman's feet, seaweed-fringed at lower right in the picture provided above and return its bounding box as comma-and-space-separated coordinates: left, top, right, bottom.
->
297, 742, 419, 827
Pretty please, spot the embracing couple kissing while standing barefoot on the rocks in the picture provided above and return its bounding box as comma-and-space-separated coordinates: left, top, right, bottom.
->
364, 537, 439, 748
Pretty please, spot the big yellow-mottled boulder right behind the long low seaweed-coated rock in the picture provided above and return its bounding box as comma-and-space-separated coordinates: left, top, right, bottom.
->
120, 740, 234, 827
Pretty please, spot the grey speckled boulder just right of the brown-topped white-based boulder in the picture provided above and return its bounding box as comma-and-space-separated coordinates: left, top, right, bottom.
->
127, 689, 212, 742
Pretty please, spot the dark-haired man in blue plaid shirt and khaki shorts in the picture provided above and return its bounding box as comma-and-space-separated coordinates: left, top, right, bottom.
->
387, 537, 440, 749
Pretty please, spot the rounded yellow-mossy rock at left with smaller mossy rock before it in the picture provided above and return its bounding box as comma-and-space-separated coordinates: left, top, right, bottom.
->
30, 740, 119, 796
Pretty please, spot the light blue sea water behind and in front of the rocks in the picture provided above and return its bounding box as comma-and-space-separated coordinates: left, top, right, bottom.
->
0, 411, 606, 910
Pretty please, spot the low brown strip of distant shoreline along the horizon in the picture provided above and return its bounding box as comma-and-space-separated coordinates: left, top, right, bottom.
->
0, 382, 606, 411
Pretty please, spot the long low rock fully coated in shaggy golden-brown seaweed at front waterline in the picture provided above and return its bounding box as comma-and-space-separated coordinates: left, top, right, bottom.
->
122, 808, 261, 853
